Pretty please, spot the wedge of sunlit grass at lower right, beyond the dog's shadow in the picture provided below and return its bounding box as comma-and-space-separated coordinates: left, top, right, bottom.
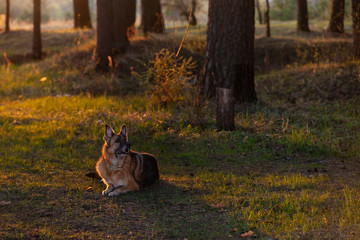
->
161, 169, 360, 238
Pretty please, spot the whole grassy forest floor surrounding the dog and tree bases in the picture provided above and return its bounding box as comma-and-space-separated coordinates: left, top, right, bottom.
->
0, 22, 360, 239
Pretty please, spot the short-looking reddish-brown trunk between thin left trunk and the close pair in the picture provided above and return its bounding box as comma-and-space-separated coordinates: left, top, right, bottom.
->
73, 0, 92, 28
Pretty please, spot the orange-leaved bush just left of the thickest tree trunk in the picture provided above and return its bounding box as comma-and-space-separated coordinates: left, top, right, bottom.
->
141, 49, 207, 128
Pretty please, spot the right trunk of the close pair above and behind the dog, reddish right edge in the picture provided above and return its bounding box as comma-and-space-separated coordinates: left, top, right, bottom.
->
113, 0, 136, 53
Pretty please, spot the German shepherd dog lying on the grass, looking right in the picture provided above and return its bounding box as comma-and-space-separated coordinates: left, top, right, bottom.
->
96, 125, 159, 196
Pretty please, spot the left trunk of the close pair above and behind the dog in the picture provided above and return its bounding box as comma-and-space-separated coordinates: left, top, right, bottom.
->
96, 0, 114, 71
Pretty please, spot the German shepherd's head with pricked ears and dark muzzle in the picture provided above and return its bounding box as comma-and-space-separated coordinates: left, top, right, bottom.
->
104, 124, 131, 156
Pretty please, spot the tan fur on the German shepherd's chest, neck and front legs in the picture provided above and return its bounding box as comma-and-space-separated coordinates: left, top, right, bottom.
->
96, 138, 140, 196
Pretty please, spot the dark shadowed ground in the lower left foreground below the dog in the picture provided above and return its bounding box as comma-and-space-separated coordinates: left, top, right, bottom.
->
0, 173, 258, 239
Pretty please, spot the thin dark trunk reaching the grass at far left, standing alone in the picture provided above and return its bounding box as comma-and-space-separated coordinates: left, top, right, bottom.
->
33, 0, 42, 59
